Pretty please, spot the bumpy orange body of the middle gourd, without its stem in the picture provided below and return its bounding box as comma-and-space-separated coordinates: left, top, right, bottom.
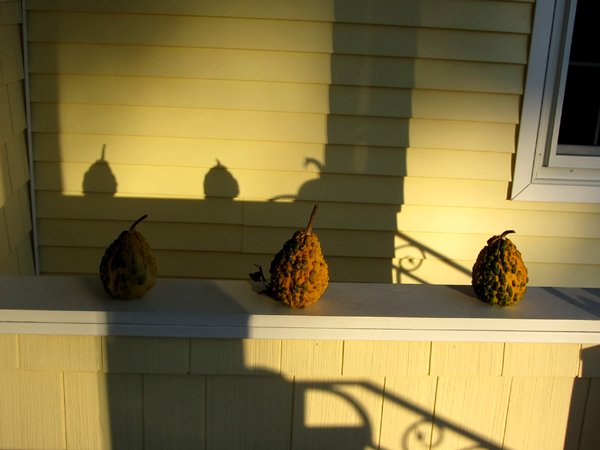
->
269, 230, 329, 308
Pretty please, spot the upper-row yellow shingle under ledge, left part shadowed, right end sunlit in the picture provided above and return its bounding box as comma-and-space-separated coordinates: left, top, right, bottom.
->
190, 339, 281, 375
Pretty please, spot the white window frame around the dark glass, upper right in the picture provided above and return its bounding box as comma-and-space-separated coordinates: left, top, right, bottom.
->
511, 0, 600, 203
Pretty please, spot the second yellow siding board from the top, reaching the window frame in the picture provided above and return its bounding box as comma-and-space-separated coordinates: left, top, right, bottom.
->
29, 12, 527, 63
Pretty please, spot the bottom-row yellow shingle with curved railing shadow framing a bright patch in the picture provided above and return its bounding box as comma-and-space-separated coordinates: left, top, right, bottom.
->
291, 377, 383, 450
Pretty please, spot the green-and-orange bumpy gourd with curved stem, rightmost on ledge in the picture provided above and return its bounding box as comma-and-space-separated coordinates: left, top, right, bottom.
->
472, 231, 529, 306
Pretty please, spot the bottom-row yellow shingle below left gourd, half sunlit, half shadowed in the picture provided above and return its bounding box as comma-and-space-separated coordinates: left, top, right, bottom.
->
64, 372, 144, 450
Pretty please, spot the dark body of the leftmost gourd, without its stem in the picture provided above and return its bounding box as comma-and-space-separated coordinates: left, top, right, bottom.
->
100, 217, 158, 300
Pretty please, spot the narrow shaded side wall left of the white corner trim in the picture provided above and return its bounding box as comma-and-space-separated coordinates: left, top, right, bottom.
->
0, 1, 35, 274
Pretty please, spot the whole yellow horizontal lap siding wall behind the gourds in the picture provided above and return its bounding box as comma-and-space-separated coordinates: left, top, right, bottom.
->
28, 0, 600, 286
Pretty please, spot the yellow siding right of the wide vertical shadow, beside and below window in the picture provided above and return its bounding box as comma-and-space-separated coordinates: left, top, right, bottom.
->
394, 1, 600, 286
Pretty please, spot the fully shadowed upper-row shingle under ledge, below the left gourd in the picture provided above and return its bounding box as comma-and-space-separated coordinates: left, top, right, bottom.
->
102, 336, 190, 373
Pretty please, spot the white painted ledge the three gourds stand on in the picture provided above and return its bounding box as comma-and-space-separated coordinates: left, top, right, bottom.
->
0, 276, 600, 343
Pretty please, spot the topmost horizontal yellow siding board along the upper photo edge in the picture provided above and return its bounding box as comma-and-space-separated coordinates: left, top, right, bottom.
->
29, 0, 532, 32
